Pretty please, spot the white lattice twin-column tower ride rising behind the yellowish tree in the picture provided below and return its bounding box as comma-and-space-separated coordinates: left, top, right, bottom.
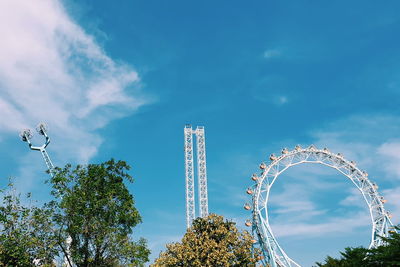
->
184, 125, 208, 228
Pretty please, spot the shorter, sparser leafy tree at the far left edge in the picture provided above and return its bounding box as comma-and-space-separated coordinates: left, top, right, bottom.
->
0, 183, 58, 267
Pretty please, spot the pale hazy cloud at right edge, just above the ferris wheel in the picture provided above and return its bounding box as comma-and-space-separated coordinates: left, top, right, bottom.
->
311, 115, 400, 180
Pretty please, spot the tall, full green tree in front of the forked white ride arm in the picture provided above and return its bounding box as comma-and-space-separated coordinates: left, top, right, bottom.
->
51, 160, 150, 267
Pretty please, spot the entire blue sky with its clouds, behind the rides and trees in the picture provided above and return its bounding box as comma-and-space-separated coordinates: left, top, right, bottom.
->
0, 0, 400, 266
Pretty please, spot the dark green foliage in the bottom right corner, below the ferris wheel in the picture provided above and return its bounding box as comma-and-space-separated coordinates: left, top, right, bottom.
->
316, 226, 400, 267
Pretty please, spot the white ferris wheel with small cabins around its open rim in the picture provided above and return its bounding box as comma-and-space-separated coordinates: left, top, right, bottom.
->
244, 145, 395, 267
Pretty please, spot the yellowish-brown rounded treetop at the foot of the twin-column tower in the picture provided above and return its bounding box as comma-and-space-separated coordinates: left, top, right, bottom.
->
151, 214, 256, 267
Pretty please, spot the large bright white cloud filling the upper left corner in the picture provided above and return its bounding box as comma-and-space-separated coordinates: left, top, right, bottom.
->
0, 0, 148, 164
